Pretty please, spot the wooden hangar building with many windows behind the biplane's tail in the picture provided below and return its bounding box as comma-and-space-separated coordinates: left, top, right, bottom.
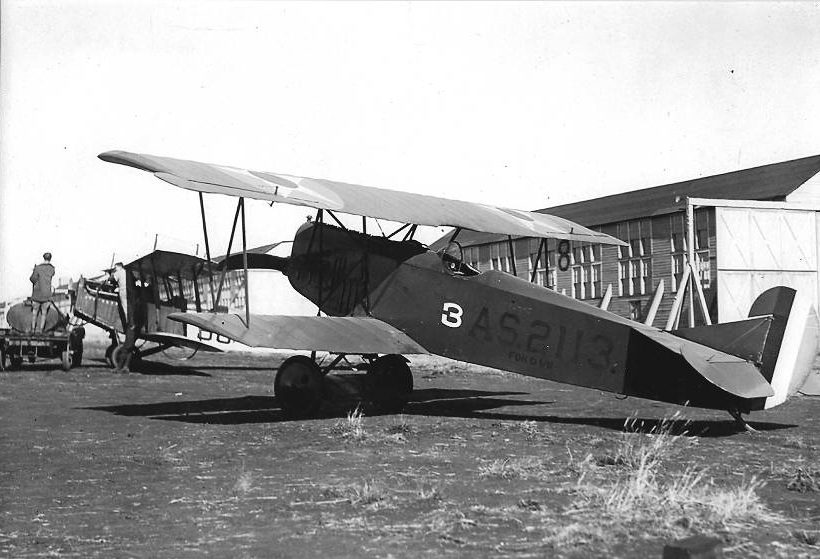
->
431, 155, 820, 328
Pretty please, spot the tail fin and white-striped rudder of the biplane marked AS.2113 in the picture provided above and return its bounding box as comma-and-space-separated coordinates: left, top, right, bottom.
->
674, 286, 820, 409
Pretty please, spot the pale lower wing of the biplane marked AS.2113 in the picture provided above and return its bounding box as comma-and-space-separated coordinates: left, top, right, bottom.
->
169, 313, 427, 354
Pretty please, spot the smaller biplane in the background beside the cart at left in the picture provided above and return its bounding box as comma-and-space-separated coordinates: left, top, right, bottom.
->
74, 250, 221, 370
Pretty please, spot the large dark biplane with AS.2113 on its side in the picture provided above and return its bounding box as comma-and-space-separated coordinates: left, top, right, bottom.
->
99, 151, 818, 428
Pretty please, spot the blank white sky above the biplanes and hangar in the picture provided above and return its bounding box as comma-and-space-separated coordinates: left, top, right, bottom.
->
0, 0, 820, 300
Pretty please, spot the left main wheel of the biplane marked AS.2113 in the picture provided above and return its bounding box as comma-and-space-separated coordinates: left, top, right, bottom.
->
273, 355, 324, 417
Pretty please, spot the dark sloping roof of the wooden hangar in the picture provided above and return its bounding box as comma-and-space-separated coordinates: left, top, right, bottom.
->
442, 155, 820, 249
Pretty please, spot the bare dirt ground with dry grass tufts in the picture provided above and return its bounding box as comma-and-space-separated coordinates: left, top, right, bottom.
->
0, 346, 820, 558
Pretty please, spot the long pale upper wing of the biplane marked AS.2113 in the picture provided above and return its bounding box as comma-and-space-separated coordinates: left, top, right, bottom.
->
99, 151, 624, 245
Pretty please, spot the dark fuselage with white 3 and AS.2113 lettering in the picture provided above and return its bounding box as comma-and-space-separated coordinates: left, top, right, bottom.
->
287, 224, 748, 409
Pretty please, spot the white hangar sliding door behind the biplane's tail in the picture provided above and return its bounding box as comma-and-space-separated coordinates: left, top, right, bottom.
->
715, 207, 818, 322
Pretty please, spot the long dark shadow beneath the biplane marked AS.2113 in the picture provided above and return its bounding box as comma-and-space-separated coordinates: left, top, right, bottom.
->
82, 388, 796, 438
